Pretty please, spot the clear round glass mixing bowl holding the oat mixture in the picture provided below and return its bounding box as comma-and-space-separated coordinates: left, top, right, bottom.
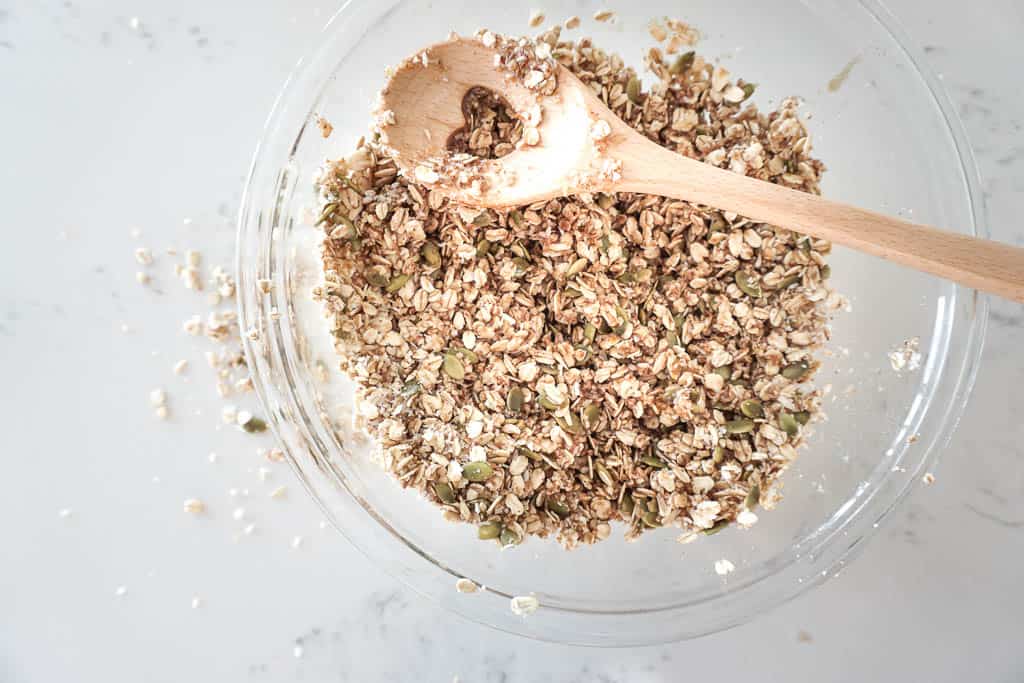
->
238, 0, 986, 645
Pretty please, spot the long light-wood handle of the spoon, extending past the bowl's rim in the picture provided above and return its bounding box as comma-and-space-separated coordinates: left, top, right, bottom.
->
614, 140, 1024, 303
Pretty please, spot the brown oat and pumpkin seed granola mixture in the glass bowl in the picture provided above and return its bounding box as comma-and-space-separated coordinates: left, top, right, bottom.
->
316, 27, 842, 547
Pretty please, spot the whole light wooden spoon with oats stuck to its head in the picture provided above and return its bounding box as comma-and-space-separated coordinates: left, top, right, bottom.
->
379, 38, 1024, 302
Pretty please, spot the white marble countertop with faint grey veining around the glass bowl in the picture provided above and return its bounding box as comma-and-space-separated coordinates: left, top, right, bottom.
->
0, 0, 1024, 683
